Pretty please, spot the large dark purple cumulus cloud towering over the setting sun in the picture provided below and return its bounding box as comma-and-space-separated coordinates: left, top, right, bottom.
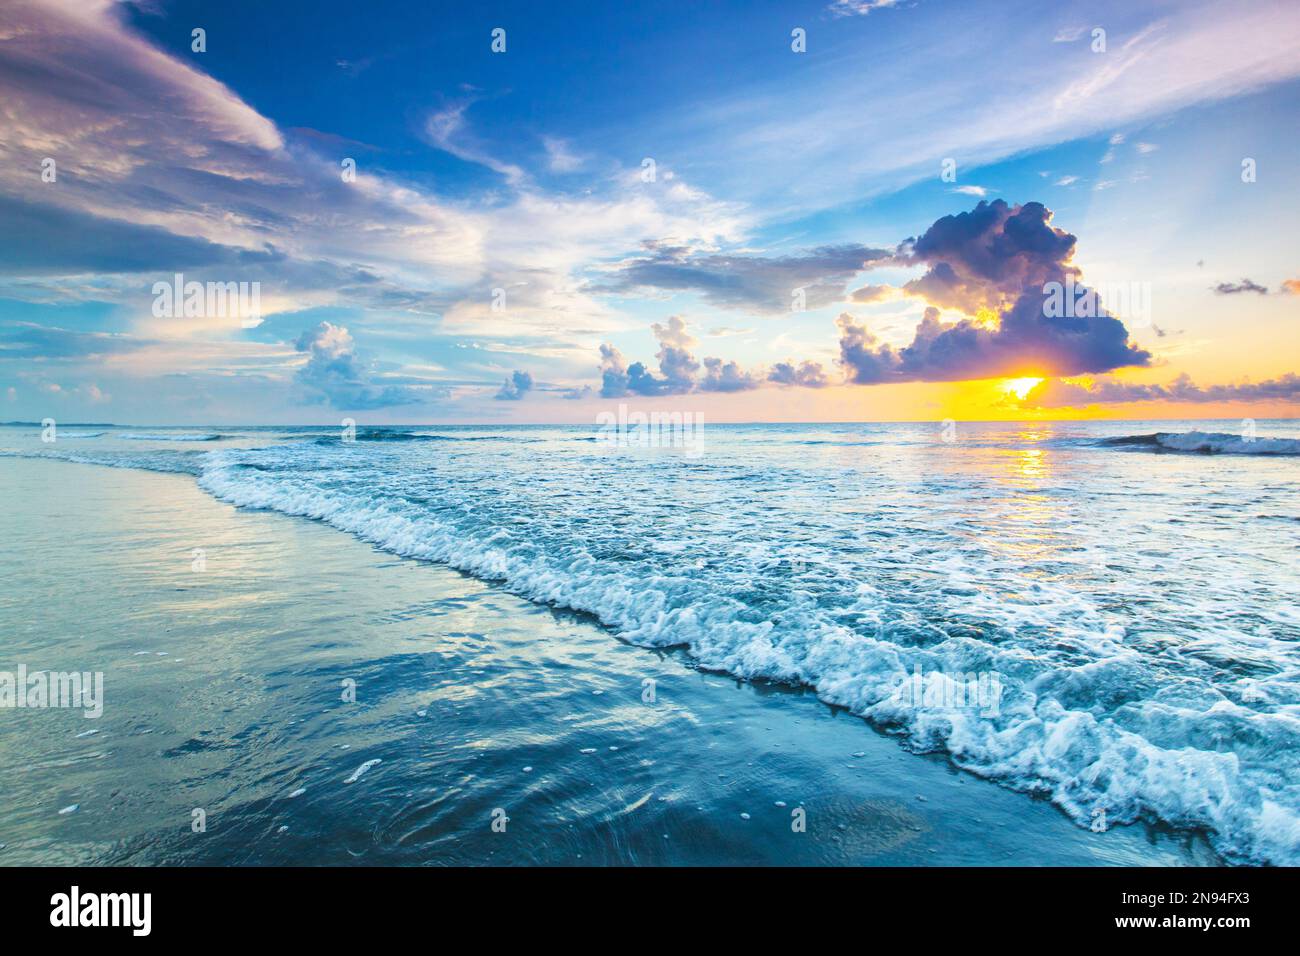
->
839, 199, 1151, 385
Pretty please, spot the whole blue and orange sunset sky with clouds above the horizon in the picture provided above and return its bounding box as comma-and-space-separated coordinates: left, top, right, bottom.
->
0, 0, 1300, 424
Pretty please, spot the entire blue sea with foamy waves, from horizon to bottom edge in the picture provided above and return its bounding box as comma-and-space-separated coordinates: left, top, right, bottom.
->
0, 420, 1300, 865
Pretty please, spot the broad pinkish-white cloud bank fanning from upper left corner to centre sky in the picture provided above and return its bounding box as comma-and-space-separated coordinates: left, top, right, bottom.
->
0, 0, 748, 414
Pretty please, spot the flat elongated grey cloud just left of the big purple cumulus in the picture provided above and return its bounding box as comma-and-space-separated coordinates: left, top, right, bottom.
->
601, 242, 893, 313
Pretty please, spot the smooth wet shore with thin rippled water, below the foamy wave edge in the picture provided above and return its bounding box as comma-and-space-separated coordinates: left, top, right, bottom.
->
0, 458, 1221, 865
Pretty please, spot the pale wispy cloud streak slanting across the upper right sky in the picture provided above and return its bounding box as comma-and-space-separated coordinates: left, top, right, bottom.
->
660, 0, 1300, 210
